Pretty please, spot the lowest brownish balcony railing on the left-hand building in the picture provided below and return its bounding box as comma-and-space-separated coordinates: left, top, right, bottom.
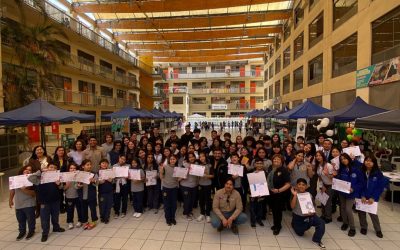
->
44, 89, 138, 109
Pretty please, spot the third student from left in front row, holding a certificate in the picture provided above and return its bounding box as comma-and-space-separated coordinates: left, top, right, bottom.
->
64, 163, 82, 230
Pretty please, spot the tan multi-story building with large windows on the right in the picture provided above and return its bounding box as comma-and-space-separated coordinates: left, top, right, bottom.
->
264, 0, 400, 109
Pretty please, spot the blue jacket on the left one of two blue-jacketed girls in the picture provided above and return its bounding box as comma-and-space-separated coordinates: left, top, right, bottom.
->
336, 166, 364, 199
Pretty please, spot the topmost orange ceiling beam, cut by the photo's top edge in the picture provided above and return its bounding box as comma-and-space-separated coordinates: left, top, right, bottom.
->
72, 0, 283, 13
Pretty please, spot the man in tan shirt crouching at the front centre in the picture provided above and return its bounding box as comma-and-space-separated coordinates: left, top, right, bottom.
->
211, 178, 247, 234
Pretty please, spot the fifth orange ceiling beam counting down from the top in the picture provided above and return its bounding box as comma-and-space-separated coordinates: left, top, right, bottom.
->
137, 47, 268, 57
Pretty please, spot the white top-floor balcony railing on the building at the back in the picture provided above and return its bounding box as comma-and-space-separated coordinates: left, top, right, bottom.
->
166, 70, 263, 79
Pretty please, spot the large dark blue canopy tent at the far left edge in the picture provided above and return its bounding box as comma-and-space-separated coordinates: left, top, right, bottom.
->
0, 99, 95, 146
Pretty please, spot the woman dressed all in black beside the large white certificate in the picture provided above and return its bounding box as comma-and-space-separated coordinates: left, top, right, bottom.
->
267, 155, 290, 235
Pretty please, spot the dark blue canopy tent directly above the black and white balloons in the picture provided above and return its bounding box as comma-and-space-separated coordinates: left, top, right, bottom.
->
309, 96, 387, 122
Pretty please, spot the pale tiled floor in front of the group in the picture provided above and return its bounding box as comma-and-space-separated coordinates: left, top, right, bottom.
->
0, 197, 400, 250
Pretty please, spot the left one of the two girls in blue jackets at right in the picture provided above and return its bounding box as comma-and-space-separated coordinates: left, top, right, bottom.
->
336, 153, 364, 237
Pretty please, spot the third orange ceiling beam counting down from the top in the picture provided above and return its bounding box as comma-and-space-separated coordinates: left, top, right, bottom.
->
115, 26, 282, 41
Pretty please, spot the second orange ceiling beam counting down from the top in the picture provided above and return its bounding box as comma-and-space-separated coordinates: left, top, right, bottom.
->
97, 10, 292, 29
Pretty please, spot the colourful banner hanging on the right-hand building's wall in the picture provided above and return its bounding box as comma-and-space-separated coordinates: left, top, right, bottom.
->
356, 57, 400, 89
